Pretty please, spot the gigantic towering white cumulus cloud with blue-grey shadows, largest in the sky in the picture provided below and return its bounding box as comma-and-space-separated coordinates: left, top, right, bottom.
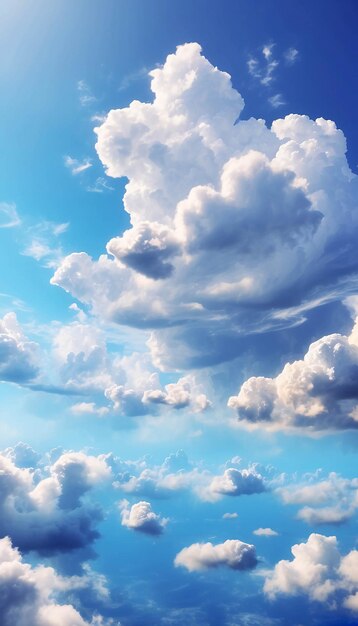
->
52, 43, 358, 370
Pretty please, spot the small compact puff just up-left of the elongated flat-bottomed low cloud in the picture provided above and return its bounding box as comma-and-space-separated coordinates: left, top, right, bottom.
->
119, 500, 168, 535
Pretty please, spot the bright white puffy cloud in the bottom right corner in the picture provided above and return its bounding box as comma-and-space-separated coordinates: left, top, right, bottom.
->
264, 533, 358, 610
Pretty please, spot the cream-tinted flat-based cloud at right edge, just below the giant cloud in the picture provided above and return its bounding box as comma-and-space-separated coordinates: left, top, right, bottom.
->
228, 316, 358, 431
